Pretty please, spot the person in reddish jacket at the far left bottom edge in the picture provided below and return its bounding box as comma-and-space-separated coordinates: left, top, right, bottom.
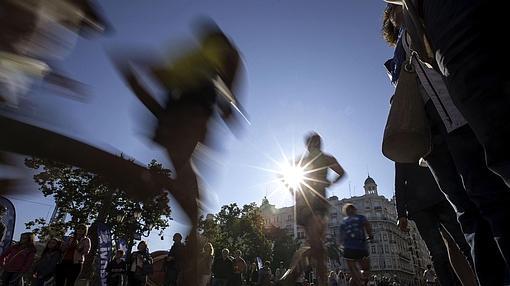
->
0, 232, 36, 286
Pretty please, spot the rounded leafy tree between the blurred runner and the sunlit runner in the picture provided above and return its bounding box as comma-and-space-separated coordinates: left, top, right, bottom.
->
199, 203, 271, 261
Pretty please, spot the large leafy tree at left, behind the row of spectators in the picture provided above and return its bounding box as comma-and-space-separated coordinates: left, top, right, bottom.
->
25, 158, 171, 278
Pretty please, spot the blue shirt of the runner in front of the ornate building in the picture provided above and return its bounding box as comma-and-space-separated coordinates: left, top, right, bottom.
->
340, 215, 367, 249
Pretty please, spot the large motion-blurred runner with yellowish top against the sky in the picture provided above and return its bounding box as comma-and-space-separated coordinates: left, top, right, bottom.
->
112, 20, 245, 285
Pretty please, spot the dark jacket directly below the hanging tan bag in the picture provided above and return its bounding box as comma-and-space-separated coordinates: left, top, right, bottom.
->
395, 163, 446, 218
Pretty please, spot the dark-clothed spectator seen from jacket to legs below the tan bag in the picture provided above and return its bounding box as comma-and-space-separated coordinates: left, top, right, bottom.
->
395, 163, 475, 285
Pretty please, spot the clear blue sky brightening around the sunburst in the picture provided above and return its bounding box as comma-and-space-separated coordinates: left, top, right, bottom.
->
11, 0, 394, 249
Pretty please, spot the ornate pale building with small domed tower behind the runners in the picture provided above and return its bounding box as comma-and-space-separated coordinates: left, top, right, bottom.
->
260, 176, 431, 285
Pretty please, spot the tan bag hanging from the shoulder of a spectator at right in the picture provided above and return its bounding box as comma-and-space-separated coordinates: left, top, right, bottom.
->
382, 52, 431, 163
